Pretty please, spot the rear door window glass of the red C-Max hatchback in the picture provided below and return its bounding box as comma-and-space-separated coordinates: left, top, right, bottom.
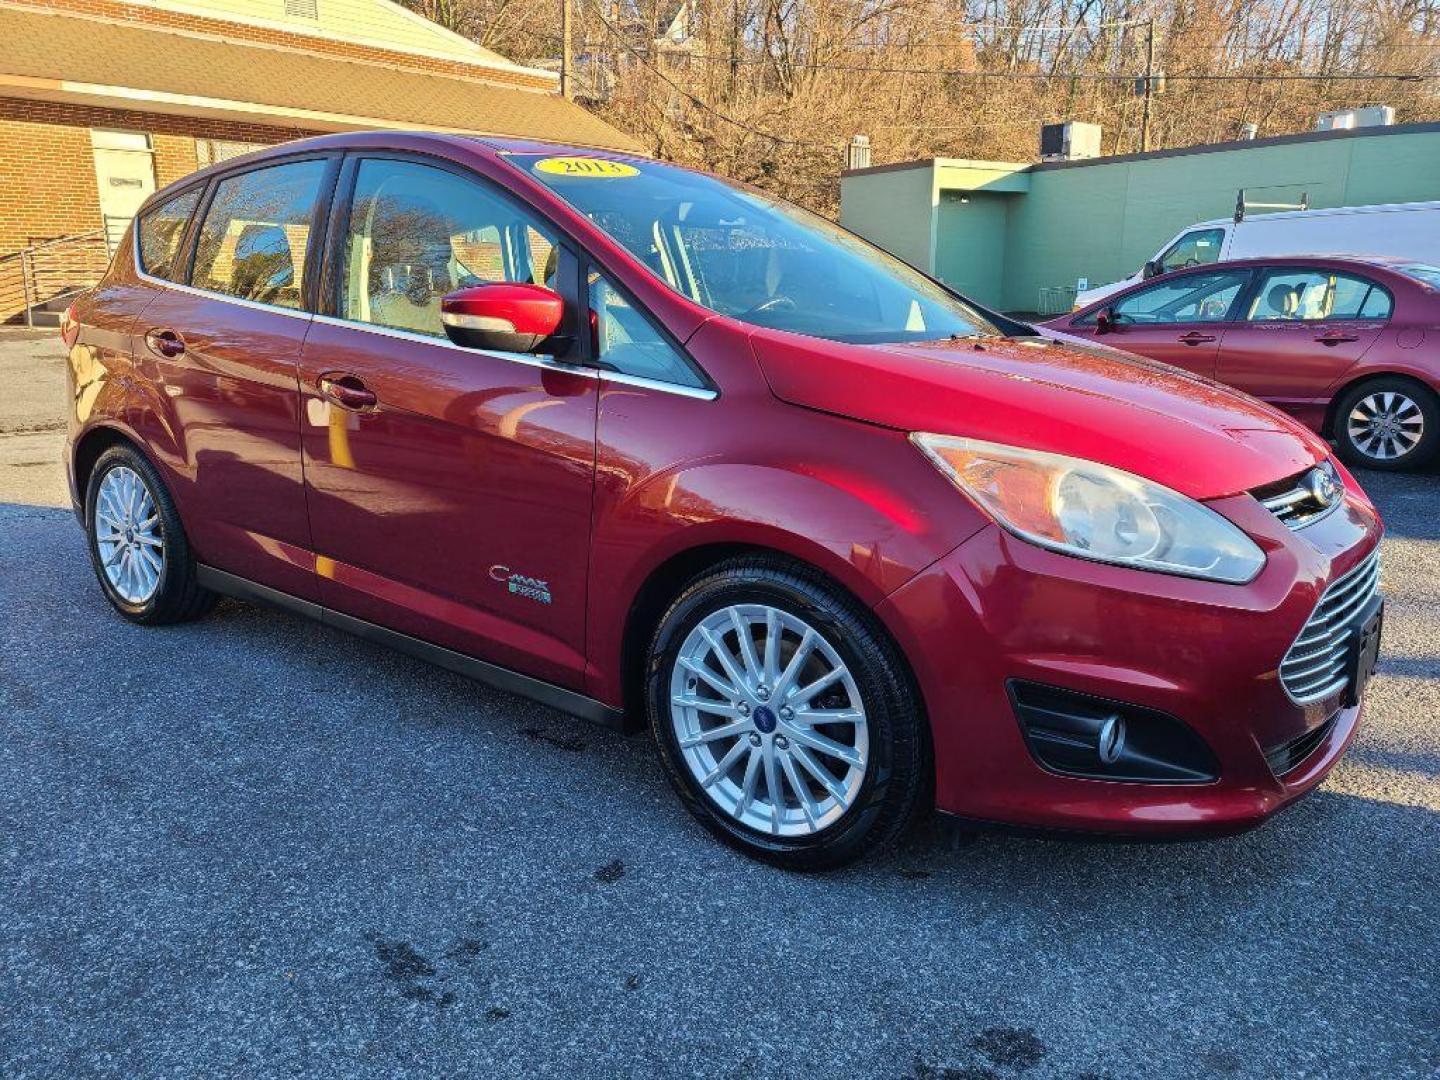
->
192, 161, 327, 308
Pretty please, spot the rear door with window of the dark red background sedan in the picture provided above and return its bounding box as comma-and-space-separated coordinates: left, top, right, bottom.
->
1217, 266, 1391, 413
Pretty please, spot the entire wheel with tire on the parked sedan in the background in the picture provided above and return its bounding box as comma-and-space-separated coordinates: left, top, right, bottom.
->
1335, 379, 1440, 471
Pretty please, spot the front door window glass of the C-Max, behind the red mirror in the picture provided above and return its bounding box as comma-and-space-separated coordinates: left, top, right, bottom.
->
340, 158, 556, 337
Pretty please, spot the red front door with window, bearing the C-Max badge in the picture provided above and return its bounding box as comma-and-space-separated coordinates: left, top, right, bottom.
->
301, 157, 598, 688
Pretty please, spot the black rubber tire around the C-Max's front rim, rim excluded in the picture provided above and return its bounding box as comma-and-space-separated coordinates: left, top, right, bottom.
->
645, 556, 933, 870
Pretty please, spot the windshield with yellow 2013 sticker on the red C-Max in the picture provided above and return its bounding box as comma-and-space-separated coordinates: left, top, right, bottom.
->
510, 154, 999, 343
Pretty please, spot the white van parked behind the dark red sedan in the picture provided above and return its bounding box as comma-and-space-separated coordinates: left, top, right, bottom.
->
1074, 192, 1440, 311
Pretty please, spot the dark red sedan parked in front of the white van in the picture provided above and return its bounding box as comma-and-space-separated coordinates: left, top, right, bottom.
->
1045, 256, 1440, 469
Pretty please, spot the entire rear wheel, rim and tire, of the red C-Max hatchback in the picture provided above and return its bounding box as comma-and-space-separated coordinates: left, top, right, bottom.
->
85, 445, 216, 624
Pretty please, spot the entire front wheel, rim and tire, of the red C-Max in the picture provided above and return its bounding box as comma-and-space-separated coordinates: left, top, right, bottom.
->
648, 559, 927, 870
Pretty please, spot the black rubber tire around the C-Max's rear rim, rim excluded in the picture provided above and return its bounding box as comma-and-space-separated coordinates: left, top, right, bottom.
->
85, 444, 219, 626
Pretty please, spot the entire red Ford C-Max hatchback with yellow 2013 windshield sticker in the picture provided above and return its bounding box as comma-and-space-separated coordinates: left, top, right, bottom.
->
63, 134, 1381, 867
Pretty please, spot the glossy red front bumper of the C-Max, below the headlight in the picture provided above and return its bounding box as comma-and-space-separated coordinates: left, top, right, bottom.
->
878, 495, 1381, 837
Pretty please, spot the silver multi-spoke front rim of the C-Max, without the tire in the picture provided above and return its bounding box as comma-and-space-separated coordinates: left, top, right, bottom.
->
670, 603, 870, 837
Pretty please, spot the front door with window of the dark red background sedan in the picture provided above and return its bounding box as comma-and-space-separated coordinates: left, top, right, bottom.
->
1064, 269, 1250, 377
